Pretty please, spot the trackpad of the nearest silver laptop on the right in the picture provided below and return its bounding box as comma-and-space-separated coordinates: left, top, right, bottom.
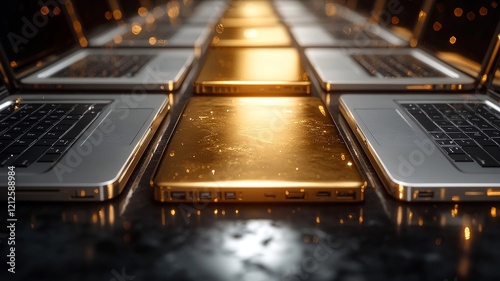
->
355, 109, 421, 146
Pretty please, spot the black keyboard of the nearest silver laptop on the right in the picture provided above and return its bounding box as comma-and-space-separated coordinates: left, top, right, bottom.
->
403, 103, 500, 167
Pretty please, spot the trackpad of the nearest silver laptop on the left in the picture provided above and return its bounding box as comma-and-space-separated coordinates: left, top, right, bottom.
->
82, 108, 153, 145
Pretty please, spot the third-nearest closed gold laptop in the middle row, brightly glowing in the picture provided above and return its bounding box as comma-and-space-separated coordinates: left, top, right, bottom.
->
211, 24, 292, 47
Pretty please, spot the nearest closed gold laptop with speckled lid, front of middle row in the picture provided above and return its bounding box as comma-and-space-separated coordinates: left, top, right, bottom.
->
151, 97, 366, 203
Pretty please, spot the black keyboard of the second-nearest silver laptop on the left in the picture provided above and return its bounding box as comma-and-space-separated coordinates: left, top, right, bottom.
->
52, 55, 154, 77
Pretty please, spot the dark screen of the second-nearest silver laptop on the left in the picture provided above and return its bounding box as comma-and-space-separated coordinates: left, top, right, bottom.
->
0, 0, 76, 74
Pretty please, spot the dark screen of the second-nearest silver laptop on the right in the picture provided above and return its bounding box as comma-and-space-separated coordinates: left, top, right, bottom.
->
419, 0, 500, 77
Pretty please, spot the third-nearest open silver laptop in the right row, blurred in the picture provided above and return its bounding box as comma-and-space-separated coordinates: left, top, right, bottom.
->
290, 0, 426, 48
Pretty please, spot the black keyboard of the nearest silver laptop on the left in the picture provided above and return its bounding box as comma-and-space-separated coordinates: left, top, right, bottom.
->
0, 103, 106, 167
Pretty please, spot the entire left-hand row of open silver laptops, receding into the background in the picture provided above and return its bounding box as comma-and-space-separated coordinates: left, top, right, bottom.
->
0, 0, 229, 201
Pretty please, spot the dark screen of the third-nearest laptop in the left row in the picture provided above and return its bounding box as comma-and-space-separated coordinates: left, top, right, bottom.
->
72, 0, 121, 34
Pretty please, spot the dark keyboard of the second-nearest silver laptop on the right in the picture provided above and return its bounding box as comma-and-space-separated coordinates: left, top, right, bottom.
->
352, 54, 444, 78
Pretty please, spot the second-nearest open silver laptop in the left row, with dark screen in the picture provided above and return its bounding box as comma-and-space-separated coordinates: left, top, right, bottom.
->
0, 0, 195, 91
